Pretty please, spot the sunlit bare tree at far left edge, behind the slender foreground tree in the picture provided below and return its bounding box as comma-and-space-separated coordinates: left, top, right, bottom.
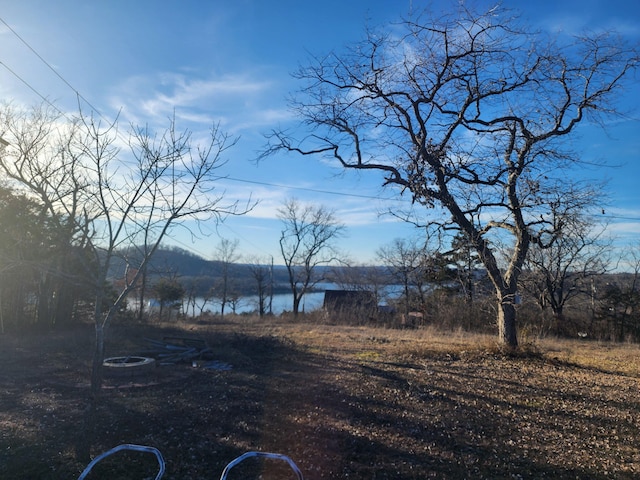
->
0, 105, 93, 325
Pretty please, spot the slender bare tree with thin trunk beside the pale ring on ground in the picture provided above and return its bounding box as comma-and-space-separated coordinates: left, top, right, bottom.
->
0, 107, 250, 457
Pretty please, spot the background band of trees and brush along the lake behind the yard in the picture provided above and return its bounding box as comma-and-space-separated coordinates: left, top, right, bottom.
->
0, 160, 640, 341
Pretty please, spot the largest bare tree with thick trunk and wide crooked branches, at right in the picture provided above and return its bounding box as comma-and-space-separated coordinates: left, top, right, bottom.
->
264, 6, 638, 347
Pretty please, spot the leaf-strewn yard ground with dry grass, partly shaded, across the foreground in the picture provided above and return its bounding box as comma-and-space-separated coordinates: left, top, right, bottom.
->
0, 319, 640, 480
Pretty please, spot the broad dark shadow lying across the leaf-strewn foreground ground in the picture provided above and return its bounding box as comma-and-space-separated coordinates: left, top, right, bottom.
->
0, 324, 631, 480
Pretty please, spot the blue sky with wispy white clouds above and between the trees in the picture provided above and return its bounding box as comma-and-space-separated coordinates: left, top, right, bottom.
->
0, 0, 640, 263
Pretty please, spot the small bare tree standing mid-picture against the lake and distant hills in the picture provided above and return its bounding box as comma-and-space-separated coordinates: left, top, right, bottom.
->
278, 199, 345, 317
